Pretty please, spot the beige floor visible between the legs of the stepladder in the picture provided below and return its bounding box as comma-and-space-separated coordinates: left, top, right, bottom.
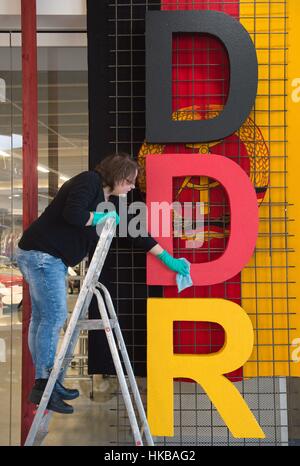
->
44, 375, 146, 446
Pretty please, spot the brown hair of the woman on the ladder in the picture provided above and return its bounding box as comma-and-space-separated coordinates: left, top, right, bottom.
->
95, 152, 139, 190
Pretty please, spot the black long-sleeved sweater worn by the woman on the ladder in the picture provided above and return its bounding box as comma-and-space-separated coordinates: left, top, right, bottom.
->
19, 171, 157, 267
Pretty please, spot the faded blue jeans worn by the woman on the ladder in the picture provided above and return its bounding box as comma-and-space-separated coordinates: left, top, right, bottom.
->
16, 248, 68, 379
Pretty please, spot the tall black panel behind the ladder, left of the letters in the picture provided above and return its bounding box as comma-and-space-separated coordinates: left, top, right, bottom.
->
87, 0, 162, 375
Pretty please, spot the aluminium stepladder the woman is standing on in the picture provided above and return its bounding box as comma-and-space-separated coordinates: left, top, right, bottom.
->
25, 218, 154, 446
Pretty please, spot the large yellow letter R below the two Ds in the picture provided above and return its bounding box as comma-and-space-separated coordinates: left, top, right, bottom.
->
147, 298, 265, 438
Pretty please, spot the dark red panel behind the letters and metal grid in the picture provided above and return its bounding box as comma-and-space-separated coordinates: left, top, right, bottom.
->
157, 0, 244, 381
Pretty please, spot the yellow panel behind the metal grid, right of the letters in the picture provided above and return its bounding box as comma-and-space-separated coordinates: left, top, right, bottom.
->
240, 0, 300, 377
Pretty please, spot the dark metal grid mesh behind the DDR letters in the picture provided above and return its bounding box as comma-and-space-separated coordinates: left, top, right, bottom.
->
108, 0, 293, 445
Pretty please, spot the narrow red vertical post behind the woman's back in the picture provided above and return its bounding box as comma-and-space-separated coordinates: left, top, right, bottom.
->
21, 0, 38, 445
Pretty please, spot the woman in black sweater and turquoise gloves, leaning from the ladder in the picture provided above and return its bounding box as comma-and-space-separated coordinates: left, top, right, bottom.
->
16, 153, 189, 414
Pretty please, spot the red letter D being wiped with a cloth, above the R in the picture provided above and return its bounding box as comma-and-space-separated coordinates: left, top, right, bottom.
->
146, 154, 258, 286
